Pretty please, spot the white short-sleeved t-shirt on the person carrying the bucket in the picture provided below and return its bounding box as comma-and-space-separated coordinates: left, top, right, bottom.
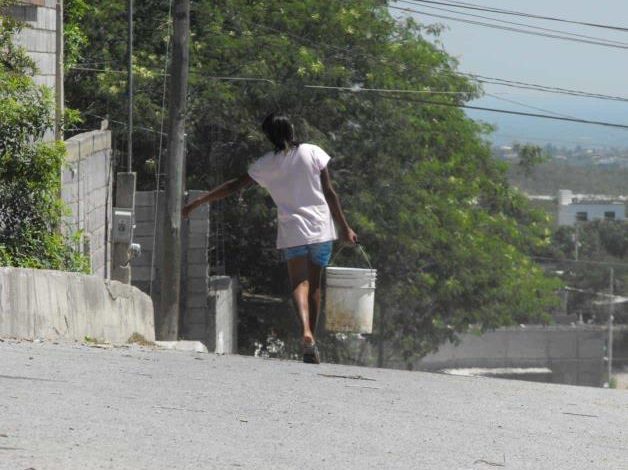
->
249, 144, 337, 249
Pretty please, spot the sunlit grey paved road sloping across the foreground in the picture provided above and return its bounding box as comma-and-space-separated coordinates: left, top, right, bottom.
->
0, 340, 628, 470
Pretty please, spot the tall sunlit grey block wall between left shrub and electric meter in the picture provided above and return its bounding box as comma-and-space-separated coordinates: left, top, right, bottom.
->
61, 130, 113, 278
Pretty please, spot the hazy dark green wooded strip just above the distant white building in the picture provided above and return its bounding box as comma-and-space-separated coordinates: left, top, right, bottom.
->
508, 161, 628, 196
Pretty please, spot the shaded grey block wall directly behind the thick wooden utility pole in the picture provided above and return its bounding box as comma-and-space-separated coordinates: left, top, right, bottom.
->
131, 191, 215, 351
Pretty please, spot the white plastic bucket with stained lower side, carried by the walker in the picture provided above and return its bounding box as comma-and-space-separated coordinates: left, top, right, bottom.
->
325, 267, 377, 333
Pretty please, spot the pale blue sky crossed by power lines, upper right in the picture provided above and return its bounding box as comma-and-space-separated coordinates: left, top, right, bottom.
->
391, 0, 628, 148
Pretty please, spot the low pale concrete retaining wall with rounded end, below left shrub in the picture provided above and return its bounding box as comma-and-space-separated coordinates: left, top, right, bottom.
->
0, 268, 155, 343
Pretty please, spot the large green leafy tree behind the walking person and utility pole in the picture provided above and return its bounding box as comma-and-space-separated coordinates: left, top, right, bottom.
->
70, 0, 557, 360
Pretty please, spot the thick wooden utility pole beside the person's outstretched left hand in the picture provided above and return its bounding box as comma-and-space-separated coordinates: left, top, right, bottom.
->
155, 0, 190, 341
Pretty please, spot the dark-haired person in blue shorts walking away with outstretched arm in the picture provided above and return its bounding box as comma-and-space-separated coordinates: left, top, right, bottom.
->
183, 114, 357, 364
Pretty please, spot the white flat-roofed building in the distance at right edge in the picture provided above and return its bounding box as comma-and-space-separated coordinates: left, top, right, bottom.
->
558, 189, 626, 225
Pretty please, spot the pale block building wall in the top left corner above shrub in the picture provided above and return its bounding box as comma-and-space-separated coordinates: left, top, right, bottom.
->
10, 0, 57, 90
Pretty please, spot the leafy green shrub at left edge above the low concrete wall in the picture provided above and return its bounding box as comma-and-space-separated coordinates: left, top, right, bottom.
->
0, 1, 87, 271
